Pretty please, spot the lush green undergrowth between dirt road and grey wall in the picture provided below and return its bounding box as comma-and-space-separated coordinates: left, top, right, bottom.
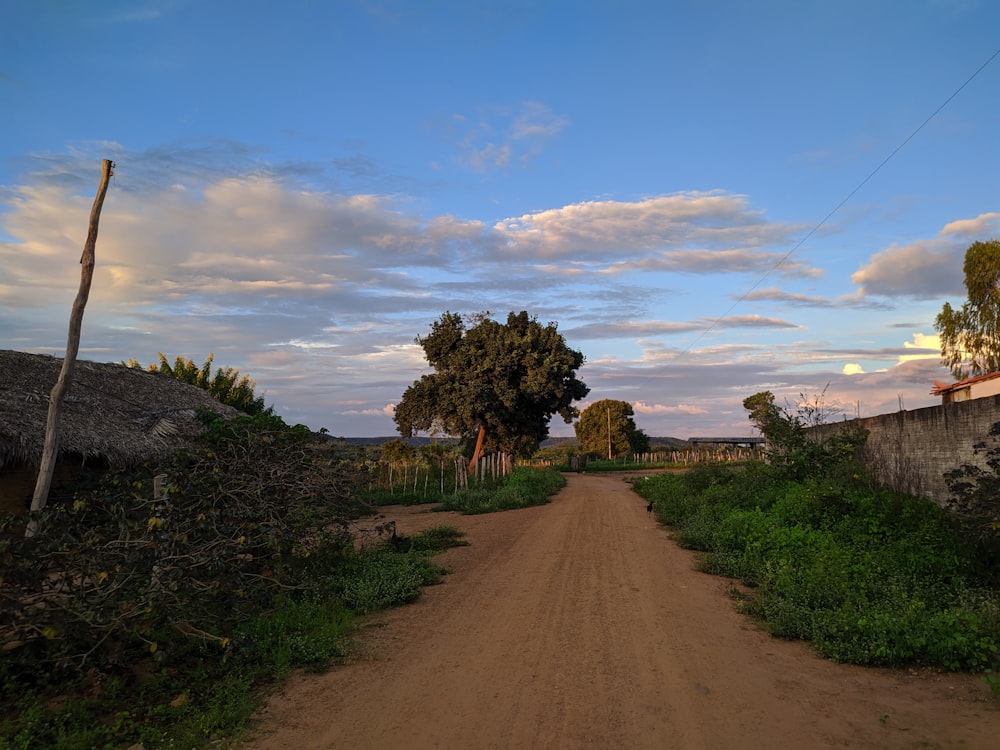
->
633, 392, 1000, 693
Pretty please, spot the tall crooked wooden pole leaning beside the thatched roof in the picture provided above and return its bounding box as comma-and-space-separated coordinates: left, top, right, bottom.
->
25, 159, 115, 536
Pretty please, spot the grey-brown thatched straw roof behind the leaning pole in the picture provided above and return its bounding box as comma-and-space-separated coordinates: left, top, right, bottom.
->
0, 349, 239, 469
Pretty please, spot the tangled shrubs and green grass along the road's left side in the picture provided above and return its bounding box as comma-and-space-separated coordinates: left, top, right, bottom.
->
0, 414, 562, 750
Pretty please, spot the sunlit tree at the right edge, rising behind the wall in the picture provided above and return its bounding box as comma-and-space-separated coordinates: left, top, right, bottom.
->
934, 240, 1000, 380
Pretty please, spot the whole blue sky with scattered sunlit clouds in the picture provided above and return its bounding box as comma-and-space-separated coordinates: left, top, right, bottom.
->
0, 0, 1000, 438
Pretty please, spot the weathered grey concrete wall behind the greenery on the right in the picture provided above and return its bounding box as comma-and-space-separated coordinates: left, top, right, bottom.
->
809, 395, 1000, 505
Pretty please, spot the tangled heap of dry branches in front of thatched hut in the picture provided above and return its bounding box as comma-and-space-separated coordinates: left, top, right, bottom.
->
0, 416, 360, 671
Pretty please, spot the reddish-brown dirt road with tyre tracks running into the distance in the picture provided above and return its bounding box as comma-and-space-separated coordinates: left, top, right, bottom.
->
246, 475, 1000, 750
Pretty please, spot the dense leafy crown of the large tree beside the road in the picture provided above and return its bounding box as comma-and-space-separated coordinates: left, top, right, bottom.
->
393, 310, 590, 456
